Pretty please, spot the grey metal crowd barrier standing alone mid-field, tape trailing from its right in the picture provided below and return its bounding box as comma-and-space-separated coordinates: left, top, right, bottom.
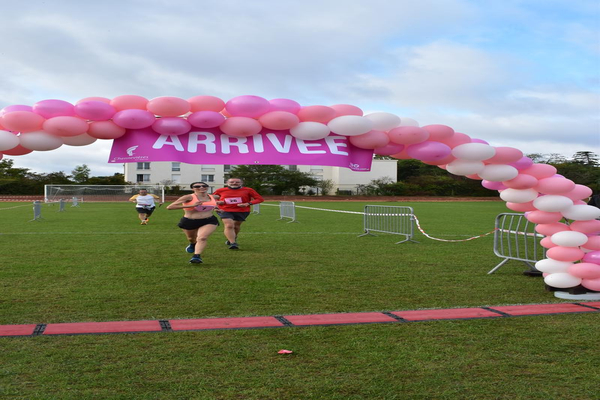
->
358, 205, 418, 244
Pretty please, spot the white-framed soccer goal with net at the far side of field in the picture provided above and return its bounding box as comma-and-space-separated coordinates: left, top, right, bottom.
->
44, 185, 165, 203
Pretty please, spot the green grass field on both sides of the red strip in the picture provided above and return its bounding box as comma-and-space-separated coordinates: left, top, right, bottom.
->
0, 202, 599, 399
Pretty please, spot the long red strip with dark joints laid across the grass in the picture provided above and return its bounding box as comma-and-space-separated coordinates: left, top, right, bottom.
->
0, 301, 600, 337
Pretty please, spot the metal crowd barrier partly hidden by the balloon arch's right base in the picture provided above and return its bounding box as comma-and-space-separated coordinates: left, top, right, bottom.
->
488, 213, 546, 275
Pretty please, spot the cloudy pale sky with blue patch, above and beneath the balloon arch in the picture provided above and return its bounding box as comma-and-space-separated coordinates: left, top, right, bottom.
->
0, 0, 600, 176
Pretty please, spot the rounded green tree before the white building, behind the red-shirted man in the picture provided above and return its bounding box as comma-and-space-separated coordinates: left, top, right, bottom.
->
227, 165, 318, 195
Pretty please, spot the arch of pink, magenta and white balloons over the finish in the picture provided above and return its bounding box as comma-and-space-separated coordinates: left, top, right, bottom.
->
0, 95, 600, 292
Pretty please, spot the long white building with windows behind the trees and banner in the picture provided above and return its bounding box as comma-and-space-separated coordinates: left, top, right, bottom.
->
123, 160, 398, 193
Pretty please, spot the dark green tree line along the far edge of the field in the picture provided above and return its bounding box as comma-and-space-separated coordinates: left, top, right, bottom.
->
0, 151, 600, 197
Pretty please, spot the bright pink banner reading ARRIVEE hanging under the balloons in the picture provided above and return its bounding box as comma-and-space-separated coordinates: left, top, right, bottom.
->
108, 129, 373, 171
